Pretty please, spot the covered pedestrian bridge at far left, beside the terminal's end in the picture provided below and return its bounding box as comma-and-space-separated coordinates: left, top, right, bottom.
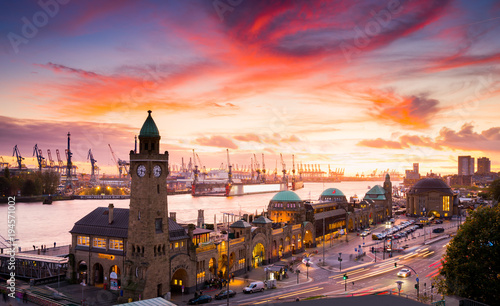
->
0, 253, 68, 285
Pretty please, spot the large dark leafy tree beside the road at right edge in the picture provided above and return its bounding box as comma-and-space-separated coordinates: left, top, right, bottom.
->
441, 205, 500, 305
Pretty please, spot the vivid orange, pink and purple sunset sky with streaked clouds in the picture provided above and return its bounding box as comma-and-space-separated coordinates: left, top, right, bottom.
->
0, 0, 500, 175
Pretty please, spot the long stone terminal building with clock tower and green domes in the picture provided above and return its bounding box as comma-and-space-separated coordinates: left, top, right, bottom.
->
67, 111, 392, 302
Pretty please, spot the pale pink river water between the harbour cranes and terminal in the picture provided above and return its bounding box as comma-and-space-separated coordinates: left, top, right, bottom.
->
0, 181, 399, 250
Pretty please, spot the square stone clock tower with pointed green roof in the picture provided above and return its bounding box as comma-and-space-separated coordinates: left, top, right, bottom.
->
123, 111, 170, 300
